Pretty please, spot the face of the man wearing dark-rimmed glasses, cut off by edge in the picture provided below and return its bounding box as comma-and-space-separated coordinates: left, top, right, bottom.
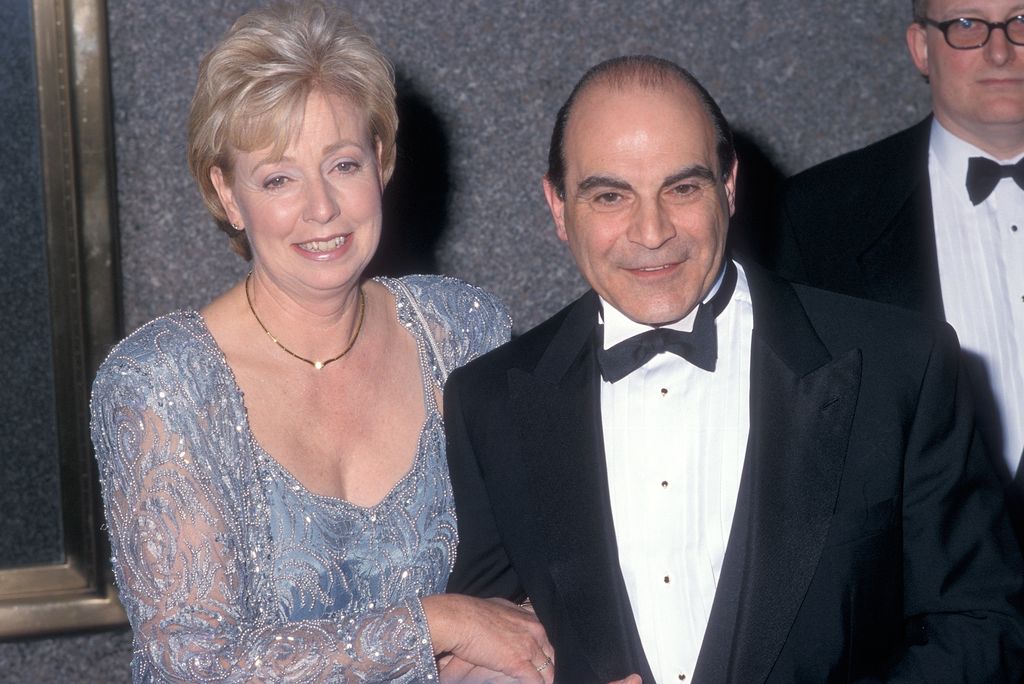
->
906, 0, 1024, 158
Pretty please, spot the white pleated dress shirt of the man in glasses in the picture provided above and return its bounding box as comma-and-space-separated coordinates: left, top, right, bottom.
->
928, 121, 1024, 475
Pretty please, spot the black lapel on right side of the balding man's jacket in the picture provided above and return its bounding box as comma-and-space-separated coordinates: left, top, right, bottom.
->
719, 269, 861, 683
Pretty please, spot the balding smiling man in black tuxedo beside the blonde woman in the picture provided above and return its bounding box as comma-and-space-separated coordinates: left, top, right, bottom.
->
444, 56, 1024, 684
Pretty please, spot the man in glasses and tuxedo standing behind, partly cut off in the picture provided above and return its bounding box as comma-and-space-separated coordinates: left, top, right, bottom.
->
775, 0, 1024, 491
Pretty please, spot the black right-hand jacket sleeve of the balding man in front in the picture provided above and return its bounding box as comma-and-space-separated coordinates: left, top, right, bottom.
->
887, 327, 1024, 682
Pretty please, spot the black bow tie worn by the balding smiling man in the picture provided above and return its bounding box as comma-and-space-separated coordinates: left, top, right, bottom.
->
597, 261, 736, 382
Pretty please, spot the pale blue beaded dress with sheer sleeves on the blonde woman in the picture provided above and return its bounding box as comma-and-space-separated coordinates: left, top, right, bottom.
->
91, 275, 510, 682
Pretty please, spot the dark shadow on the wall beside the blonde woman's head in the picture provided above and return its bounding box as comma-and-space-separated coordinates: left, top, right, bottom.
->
367, 74, 452, 275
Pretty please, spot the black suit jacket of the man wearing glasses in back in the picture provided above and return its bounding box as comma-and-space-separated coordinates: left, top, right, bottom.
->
765, 117, 1024, 491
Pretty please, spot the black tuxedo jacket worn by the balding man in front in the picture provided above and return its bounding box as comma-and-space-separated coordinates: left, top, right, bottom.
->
444, 267, 1024, 684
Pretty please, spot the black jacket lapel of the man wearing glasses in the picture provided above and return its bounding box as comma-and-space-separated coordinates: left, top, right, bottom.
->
858, 118, 943, 318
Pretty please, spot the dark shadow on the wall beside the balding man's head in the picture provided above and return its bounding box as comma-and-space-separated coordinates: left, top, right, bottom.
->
729, 130, 784, 264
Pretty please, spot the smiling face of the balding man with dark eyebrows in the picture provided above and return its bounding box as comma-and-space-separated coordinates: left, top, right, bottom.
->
544, 83, 736, 326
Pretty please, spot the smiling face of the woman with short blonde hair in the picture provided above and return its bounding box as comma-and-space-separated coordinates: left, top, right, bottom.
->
211, 91, 384, 300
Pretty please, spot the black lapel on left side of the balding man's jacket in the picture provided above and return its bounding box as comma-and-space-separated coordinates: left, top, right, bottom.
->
509, 296, 653, 681
